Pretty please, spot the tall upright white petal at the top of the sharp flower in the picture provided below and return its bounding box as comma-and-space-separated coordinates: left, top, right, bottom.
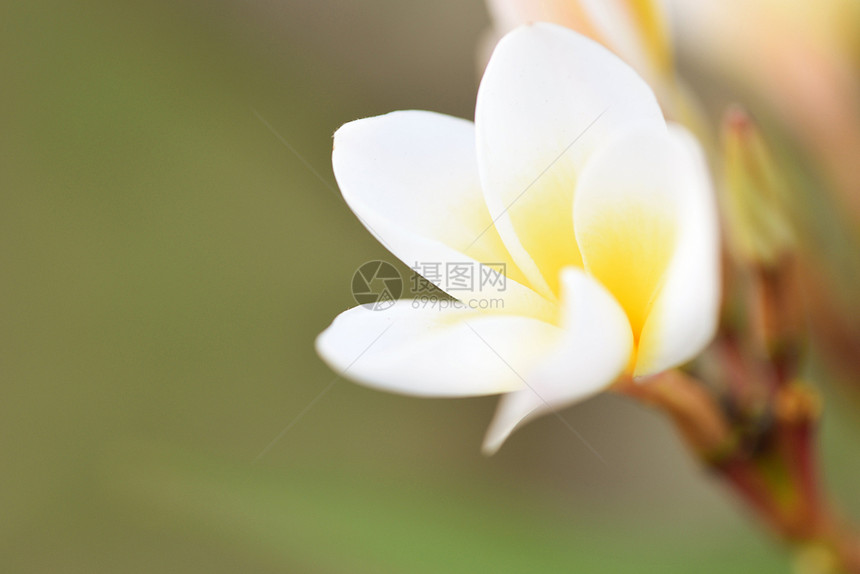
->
475, 24, 665, 297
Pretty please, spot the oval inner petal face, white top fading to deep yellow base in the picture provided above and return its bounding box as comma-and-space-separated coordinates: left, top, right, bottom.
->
573, 127, 683, 342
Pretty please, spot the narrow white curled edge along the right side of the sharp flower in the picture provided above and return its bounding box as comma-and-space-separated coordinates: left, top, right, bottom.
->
634, 125, 720, 376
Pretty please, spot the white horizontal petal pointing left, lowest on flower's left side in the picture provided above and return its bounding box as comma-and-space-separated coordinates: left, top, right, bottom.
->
316, 299, 562, 397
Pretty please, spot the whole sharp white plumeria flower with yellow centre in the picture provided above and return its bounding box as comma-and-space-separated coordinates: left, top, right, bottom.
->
317, 24, 719, 452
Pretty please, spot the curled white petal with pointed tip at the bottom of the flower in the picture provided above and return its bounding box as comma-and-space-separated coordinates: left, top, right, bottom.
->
484, 268, 633, 454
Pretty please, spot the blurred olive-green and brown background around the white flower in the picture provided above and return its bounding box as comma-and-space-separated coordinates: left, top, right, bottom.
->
0, 0, 860, 574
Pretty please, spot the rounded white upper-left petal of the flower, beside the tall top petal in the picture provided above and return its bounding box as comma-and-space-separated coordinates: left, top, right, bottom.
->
332, 111, 552, 322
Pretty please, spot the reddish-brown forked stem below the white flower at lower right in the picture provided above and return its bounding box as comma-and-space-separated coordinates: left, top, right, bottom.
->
615, 371, 860, 574
